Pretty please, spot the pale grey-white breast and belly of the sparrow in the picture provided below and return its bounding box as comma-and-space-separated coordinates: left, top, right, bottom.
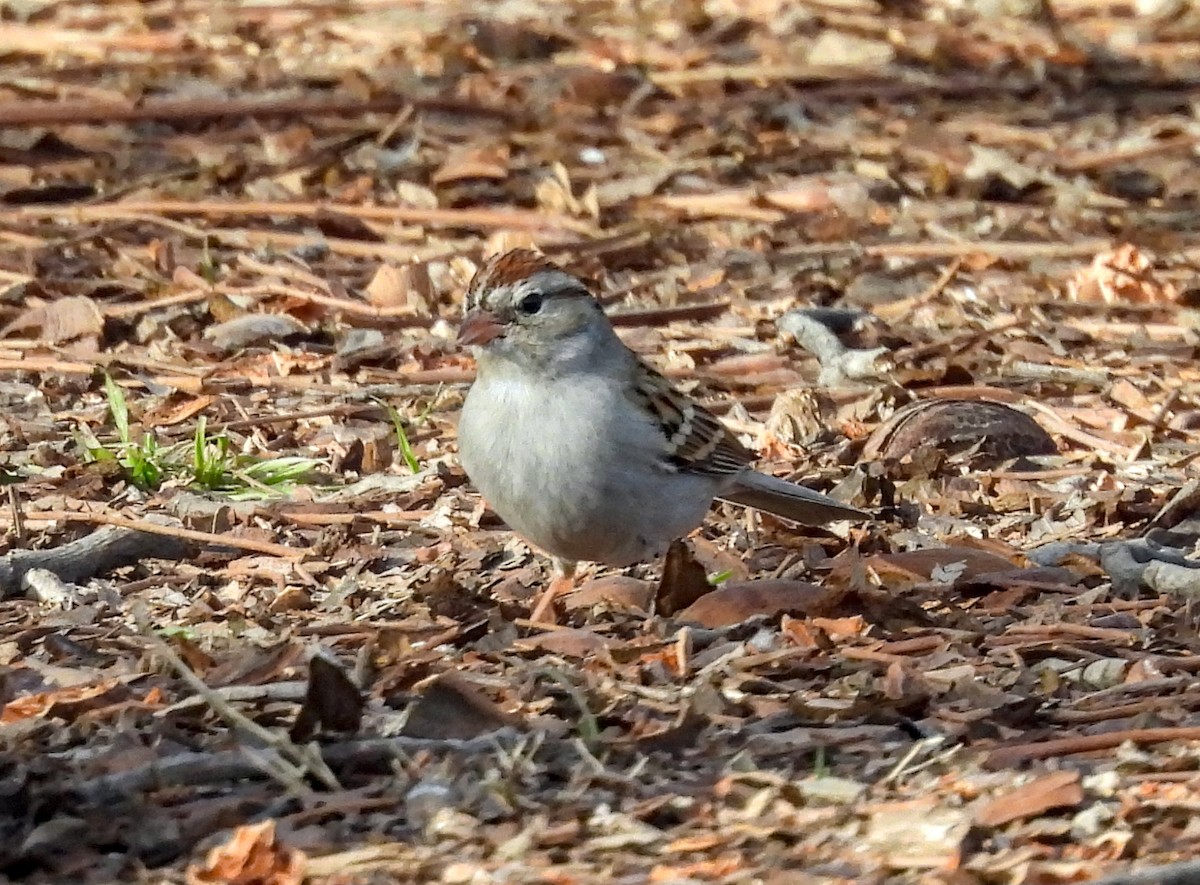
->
458, 371, 712, 565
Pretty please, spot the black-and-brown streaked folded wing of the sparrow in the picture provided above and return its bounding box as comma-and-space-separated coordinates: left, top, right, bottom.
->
634, 365, 754, 476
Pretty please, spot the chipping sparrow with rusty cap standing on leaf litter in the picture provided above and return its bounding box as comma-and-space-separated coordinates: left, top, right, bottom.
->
458, 249, 871, 574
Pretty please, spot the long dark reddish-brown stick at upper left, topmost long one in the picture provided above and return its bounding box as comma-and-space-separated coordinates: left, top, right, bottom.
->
0, 92, 511, 126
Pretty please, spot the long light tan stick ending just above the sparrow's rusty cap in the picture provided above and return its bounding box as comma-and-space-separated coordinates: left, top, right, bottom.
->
0, 200, 595, 235
